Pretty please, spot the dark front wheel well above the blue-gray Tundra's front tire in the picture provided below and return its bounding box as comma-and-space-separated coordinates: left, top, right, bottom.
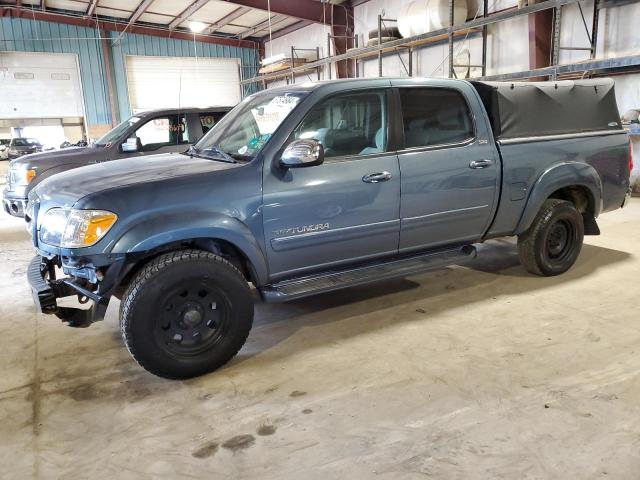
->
115, 238, 256, 298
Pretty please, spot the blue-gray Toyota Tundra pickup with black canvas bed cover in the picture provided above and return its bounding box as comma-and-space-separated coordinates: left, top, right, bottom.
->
25, 79, 632, 378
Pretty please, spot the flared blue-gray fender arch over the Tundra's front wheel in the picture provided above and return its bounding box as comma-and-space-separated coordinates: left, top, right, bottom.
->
110, 211, 268, 285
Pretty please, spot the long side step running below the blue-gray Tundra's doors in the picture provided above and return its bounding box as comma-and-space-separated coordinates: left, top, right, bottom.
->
261, 245, 476, 302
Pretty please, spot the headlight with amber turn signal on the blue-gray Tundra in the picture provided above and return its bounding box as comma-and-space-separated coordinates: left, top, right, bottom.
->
38, 208, 118, 248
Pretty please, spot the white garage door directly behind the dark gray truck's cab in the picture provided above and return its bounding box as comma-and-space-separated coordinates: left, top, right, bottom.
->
126, 56, 240, 113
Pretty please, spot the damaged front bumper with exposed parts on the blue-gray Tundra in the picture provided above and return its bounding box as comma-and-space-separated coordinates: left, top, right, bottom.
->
27, 255, 125, 327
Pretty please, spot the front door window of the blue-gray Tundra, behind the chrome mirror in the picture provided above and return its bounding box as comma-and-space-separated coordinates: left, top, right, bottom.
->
292, 91, 387, 158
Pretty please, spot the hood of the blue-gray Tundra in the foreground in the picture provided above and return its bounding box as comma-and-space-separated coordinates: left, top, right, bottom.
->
33, 153, 242, 207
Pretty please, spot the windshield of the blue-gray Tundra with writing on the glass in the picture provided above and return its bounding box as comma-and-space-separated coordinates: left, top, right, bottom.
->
189, 92, 307, 161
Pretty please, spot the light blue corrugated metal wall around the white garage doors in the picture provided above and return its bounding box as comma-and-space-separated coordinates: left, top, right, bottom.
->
0, 18, 258, 125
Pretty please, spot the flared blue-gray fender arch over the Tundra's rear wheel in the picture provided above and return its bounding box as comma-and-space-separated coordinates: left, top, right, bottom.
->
513, 162, 602, 235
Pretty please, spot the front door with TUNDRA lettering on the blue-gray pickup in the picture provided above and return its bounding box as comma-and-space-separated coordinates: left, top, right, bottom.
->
263, 89, 400, 280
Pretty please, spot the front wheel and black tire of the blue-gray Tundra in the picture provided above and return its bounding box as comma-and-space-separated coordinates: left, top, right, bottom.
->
120, 250, 253, 379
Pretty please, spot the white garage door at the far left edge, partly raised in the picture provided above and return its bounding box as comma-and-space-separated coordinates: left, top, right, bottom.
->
0, 52, 84, 119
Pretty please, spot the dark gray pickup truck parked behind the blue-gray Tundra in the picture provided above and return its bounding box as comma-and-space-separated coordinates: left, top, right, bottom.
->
3, 107, 230, 217
